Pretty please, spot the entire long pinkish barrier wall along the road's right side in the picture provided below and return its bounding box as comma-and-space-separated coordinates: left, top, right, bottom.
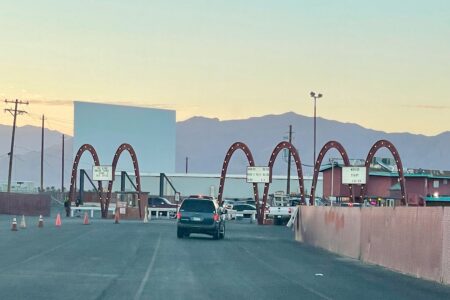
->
295, 206, 450, 284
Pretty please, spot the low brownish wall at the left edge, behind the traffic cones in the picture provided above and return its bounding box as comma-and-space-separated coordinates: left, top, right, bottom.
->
0, 193, 51, 216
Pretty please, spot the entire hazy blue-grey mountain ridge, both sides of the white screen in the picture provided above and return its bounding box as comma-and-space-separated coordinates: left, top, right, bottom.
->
0, 112, 450, 188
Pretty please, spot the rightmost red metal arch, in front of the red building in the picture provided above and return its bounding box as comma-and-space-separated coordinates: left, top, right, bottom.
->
361, 140, 408, 205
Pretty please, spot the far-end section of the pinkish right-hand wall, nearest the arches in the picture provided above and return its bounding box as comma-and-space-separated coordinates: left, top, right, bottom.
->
296, 206, 361, 258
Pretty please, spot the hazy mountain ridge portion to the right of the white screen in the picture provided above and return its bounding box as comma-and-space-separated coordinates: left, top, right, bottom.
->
177, 112, 450, 174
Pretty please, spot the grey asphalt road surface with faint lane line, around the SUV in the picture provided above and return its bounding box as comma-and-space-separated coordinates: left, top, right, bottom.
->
0, 216, 450, 300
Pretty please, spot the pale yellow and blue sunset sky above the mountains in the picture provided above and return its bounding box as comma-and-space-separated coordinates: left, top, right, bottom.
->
0, 0, 450, 135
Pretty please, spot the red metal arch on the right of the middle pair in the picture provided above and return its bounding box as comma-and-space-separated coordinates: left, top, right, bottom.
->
258, 142, 305, 224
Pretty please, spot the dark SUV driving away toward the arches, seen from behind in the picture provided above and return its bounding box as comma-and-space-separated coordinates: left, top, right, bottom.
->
177, 198, 226, 240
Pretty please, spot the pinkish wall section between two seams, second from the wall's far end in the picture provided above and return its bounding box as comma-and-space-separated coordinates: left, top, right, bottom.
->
361, 207, 444, 281
